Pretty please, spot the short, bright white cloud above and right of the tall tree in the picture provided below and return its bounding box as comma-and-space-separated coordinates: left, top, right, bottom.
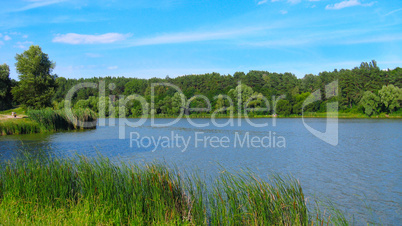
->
52, 33, 131, 45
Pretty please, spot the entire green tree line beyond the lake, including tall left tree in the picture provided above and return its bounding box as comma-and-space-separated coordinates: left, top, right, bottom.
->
0, 46, 402, 117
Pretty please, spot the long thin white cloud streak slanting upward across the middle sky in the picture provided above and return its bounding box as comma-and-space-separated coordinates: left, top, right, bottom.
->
130, 27, 269, 46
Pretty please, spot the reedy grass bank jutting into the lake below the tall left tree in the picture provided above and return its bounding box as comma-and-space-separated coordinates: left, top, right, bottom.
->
0, 109, 96, 135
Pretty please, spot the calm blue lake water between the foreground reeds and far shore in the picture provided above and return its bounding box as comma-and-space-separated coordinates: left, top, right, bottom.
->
0, 119, 402, 225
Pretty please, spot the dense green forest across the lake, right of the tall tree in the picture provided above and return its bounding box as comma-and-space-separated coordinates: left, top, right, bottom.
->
49, 61, 402, 117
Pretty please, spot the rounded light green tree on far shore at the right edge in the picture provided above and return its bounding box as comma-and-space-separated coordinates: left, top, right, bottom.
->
378, 85, 402, 113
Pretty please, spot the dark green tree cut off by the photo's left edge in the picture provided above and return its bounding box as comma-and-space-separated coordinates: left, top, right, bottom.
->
0, 64, 12, 110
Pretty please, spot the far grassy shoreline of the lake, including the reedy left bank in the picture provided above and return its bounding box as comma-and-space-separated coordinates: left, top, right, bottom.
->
0, 108, 402, 135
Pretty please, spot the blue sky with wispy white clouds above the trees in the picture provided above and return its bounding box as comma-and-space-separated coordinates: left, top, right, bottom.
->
0, 0, 402, 79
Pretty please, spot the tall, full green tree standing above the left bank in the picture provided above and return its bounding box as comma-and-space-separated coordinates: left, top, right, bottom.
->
11, 45, 56, 109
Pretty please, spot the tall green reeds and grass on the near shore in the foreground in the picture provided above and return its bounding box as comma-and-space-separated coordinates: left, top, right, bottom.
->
0, 155, 347, 225
